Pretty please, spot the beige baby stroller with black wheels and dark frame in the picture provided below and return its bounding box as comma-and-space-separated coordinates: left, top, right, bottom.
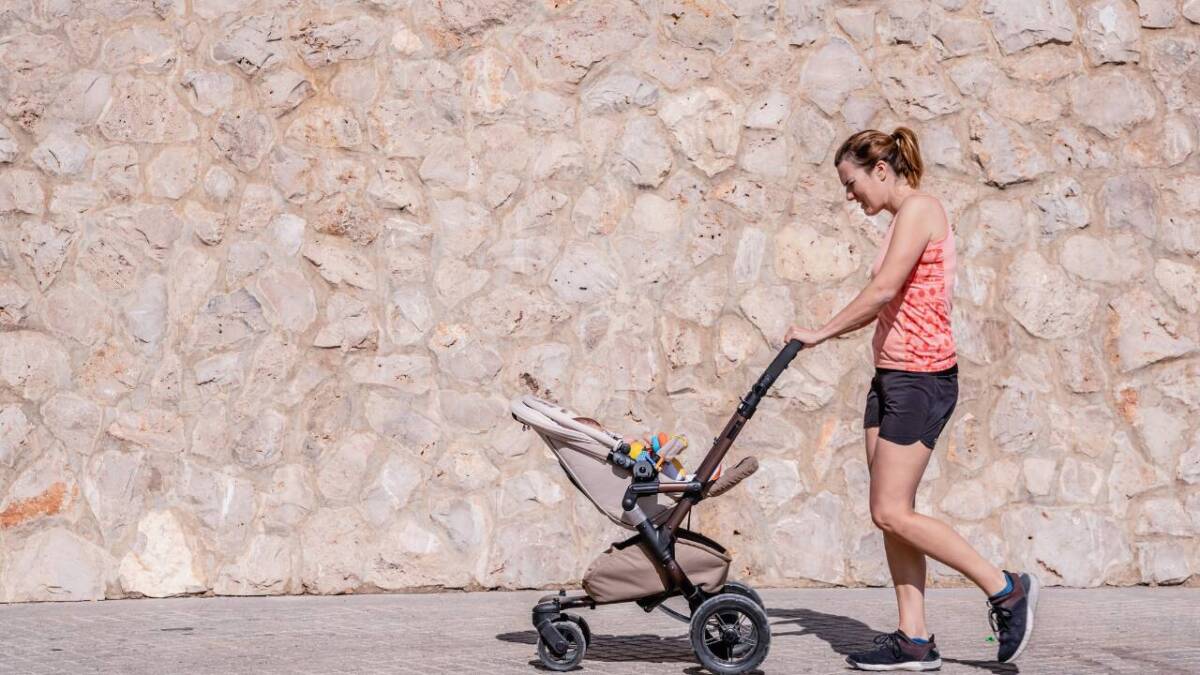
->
512, 340, 803, 675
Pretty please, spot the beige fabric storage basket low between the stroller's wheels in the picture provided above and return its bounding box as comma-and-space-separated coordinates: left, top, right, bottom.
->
583, 538, 730, 603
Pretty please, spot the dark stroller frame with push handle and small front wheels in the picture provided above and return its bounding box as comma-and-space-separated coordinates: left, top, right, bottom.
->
533, 340, 804, 656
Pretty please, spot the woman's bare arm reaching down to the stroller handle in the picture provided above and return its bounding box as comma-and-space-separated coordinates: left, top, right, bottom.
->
785, 195, 944, 346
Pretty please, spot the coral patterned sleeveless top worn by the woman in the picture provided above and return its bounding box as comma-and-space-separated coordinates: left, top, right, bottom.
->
871, 217, 958, 372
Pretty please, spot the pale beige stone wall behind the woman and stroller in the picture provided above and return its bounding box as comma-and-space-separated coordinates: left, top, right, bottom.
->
0, 0, 1200, 602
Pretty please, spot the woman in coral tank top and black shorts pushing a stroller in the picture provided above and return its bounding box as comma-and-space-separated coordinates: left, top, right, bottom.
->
787, 127, 1038, 670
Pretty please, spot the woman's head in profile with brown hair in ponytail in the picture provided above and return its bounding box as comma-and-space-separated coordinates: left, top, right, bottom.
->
833, 126, 925, 215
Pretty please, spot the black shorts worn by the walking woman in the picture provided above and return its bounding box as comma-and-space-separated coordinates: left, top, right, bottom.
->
863, 364, 959, 449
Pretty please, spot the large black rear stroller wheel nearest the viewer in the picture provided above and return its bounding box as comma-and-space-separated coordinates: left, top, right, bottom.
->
689, 593, 770, 675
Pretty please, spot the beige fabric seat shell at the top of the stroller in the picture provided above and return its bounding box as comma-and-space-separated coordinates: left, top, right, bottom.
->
511, 395, 674, 530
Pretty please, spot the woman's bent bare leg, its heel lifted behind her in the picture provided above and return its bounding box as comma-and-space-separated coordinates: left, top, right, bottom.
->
871, 438, 1007, 590
